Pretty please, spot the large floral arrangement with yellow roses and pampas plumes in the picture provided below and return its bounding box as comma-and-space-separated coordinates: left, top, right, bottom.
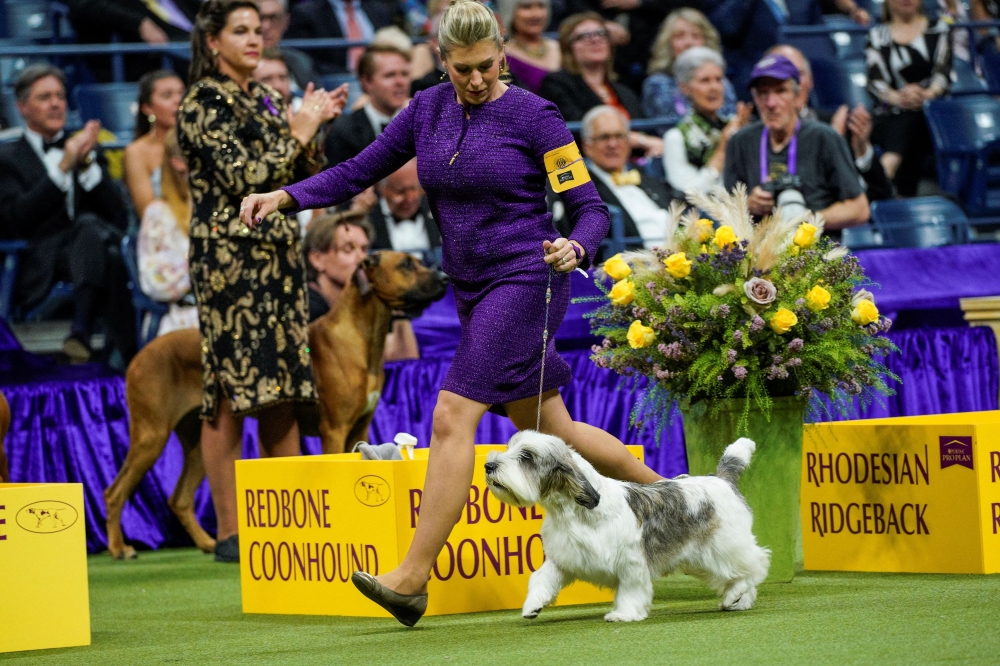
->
589, 187, 898, 424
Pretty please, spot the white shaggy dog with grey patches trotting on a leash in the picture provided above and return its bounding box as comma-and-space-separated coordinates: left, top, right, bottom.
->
486, 430, 771, 622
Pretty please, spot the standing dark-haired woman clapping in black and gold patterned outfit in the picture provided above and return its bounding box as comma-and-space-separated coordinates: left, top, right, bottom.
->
177, 0, 347, 561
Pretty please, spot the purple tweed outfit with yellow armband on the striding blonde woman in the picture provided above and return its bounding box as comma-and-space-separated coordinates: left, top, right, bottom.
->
284, 83, 609, 405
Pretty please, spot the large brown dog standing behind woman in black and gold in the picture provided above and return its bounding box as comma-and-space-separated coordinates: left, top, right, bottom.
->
104, 252, 448, 559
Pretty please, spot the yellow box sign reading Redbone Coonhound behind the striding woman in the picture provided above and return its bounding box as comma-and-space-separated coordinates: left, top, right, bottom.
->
236, 446, 642, 617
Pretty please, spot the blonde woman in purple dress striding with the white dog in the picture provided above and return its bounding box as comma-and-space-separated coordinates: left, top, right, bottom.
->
242, 0, 659, 626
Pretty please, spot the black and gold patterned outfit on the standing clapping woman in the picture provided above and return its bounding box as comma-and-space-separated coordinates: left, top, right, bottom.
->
177, 74, 321, 419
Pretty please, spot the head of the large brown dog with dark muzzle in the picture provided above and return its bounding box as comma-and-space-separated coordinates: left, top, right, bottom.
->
354, 250, 448, 318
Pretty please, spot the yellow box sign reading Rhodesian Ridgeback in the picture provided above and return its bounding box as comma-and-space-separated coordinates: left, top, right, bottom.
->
801, 411, 1000, 573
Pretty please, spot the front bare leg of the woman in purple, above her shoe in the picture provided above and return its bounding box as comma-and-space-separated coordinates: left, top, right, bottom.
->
378, 391, 489, 594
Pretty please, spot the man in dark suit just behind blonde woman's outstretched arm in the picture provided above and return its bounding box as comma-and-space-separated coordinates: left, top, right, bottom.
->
326, 44, 410, 166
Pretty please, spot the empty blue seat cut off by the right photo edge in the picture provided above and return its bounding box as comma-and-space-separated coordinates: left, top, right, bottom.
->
924, 95, 1000, 216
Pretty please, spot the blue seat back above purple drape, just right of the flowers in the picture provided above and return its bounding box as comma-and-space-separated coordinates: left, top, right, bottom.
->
872, 197, 969, 247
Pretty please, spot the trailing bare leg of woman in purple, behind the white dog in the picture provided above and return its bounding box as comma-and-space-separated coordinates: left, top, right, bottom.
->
506, 389, 663, 483
